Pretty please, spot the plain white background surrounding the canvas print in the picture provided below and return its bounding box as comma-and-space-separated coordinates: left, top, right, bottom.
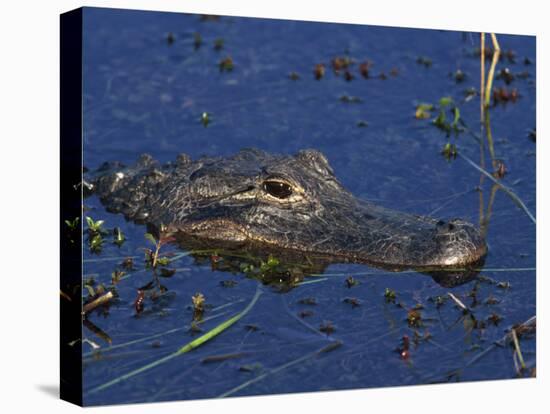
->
0, 0, 550, 414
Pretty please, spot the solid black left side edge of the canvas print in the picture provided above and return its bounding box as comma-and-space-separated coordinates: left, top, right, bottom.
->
60, 8, 83, 406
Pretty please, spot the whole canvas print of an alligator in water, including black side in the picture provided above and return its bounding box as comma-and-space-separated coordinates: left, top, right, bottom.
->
61, 8, 536, 405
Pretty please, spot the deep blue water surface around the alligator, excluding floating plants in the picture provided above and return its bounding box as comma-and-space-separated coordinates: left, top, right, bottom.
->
83, 9, 536, 405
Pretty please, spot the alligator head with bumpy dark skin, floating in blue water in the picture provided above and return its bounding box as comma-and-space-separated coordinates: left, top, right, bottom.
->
87, 149, 487, 280
